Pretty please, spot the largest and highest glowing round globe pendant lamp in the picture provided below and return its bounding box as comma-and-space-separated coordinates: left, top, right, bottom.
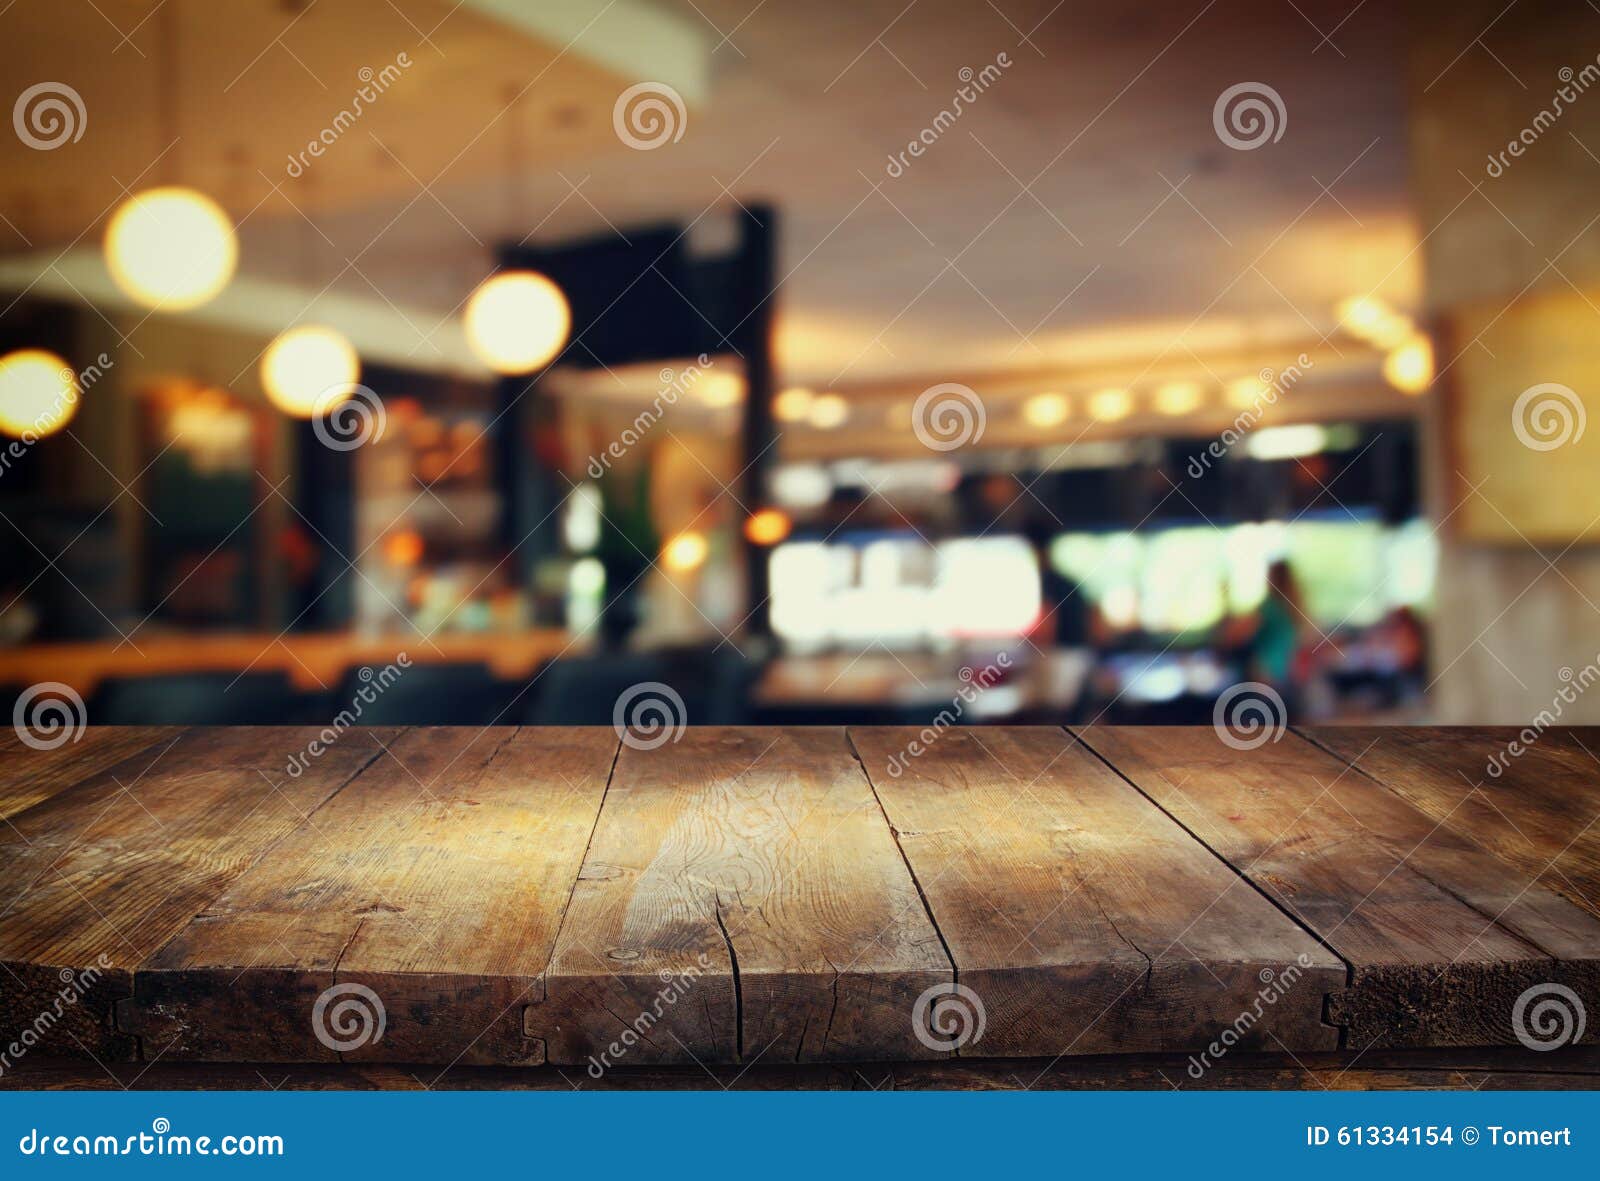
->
106, 186, 238, 312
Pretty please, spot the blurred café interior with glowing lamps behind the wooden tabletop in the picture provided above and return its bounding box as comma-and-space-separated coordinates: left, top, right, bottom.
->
0, 0, 1600, 725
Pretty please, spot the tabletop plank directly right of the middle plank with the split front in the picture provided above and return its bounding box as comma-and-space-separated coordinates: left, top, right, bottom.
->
851, 727, 1346, 1056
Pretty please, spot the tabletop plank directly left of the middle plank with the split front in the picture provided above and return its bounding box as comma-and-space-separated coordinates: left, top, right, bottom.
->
125, 727, 618, 1064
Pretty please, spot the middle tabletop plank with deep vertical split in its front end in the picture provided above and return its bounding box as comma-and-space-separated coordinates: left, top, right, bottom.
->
528, 727, 952, 1071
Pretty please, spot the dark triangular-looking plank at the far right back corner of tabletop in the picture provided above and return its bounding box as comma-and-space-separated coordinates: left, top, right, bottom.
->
1302, 727, 1600, 917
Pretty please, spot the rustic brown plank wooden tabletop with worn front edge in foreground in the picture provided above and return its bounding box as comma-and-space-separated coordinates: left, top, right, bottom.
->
0, 727, 1600, 1085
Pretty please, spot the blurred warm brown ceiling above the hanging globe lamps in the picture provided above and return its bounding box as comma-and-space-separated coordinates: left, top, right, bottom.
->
0, 0, 1419, 387
